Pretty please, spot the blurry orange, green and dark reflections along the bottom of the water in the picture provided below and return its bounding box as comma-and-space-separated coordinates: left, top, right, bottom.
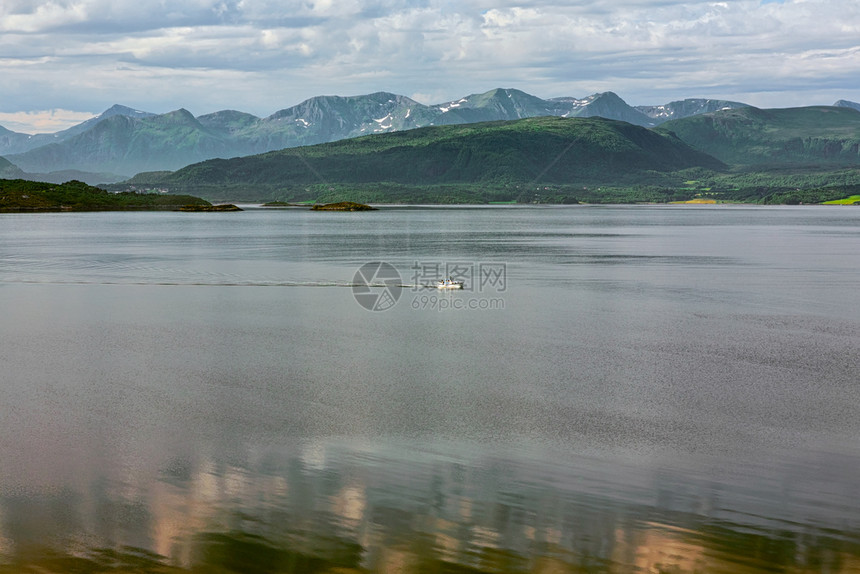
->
0, 442, 860, 574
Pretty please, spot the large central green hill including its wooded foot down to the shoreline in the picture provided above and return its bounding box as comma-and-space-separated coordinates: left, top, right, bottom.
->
117, 116, 727, 203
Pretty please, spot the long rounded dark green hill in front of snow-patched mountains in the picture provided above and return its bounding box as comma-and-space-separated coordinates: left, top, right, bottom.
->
127, 117, 725, 199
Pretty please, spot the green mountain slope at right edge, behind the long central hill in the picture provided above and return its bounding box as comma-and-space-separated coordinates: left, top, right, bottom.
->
656, 106, 860, 170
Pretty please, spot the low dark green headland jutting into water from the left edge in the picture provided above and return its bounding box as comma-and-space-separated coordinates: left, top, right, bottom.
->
0, 179, 209, 212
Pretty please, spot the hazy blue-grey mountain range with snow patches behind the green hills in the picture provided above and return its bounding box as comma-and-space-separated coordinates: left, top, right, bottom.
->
0, 89, 746, 183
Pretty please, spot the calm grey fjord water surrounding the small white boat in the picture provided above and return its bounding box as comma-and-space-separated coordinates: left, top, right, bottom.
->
0, 206, 860, 573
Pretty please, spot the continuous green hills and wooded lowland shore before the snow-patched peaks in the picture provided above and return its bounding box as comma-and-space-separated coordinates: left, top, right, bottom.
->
115, 98, 860, 203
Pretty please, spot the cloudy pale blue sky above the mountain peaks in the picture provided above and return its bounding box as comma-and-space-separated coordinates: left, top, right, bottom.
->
0, 0, 860, 133
